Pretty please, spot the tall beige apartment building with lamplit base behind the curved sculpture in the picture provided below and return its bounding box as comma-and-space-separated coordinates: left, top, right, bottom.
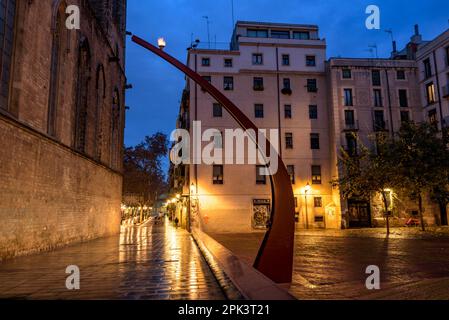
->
174, 22, 340, 232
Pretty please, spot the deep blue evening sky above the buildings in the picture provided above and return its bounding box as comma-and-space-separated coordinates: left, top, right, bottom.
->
125, 0, 449, 162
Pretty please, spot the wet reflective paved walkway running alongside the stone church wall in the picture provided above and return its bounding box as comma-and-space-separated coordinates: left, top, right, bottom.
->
0, 222, 224, 300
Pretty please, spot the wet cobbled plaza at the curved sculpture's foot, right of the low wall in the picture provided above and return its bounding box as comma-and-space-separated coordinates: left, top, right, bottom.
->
208, 230, 449, 299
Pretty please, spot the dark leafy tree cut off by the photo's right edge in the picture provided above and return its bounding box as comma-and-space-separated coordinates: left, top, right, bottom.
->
391, 122, 449, 231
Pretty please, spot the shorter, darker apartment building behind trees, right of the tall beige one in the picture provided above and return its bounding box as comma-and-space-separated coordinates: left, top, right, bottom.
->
327, 58, 434, 228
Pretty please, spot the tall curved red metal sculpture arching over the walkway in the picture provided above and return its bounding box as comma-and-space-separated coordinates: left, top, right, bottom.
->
132, 36, 295, 283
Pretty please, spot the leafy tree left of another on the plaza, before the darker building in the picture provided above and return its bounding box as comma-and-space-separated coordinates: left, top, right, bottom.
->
332, 132, 399, 234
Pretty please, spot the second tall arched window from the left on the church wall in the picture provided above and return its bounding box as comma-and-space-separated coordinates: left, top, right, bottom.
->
47, 1, 67, 137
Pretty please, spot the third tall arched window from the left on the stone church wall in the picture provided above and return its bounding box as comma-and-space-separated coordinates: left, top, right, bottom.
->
75, 39, 91, 152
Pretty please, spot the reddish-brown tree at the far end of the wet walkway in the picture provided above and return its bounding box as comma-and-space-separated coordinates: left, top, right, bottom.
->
123, 133, 168, 220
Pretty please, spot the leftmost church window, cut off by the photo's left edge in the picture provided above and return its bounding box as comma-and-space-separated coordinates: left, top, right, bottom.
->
0, 0, 16, 109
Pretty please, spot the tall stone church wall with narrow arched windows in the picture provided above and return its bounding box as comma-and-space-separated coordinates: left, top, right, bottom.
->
0, 0, 126, 259
